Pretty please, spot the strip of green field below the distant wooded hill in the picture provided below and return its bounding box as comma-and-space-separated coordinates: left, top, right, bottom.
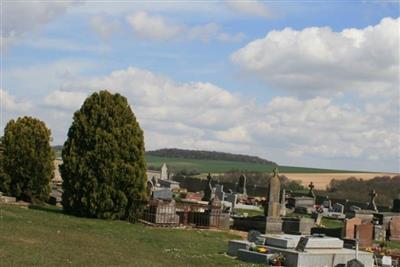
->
146, 155, 351, 173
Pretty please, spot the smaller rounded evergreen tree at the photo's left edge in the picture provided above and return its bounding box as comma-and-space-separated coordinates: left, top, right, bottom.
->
0, 117, 54, 201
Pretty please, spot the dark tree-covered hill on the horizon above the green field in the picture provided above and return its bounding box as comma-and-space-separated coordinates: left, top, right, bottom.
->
146, 148, 277, 166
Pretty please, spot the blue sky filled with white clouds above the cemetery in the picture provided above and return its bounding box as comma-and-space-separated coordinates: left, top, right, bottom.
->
0, 0, 400, 172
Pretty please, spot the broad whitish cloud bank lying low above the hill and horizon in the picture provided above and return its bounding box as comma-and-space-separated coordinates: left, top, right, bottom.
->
43, 67, 400, 172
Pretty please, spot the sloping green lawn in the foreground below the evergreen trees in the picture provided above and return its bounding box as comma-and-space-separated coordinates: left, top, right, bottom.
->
0, 204, 252, 266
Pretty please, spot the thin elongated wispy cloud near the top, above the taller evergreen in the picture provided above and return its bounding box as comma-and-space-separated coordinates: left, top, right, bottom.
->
126, 11, 244, 42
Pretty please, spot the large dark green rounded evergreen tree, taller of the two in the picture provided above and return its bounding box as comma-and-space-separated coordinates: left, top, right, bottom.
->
60, 91, 147, 221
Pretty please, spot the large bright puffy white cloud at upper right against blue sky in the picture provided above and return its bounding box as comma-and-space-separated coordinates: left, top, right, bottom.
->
231, 18, 400, 97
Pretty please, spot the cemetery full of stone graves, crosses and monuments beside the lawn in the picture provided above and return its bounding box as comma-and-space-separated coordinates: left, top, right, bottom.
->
0, 160, 400, 267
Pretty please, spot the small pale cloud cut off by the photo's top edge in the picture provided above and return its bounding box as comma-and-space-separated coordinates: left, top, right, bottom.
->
226, 0, 272, 18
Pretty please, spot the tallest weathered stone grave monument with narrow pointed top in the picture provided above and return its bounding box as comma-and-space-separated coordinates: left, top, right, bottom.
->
265, 167, 282, 234
